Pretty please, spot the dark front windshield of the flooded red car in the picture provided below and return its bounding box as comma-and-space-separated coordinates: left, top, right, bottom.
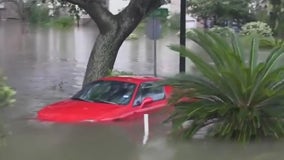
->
72, 81, 136, 105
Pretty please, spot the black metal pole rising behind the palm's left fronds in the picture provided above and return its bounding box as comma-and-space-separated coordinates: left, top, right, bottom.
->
179, 0, 186, 73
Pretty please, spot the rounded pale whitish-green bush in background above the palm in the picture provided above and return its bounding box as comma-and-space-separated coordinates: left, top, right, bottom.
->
240, 21, 273, 37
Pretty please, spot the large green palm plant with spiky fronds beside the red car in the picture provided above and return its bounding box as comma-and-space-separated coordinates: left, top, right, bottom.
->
167, 30, 284, 142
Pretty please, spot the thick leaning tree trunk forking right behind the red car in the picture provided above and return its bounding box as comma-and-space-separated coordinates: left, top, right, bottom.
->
66, 0, 166, 84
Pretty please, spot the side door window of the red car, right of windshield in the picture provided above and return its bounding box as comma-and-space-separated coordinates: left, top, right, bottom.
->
133, 82, 165, 107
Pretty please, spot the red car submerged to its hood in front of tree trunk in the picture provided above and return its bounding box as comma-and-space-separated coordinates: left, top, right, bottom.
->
37, 76, 172, 123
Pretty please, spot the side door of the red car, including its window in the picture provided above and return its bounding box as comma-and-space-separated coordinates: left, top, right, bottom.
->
133, 82, 167, 113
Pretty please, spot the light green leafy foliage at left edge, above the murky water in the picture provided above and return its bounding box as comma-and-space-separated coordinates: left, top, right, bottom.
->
0, 75, 15, 109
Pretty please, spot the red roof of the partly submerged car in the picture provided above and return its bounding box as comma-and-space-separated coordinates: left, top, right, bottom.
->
100, 75, 162, 83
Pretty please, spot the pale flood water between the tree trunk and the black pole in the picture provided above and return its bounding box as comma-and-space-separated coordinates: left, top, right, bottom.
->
115, 33, 182, 76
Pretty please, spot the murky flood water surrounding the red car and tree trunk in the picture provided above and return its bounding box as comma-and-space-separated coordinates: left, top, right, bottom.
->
0, 21, 284, 160
